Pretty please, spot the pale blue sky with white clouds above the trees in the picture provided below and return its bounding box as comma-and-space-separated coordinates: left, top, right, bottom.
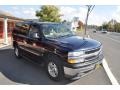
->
0, 5, 120, 25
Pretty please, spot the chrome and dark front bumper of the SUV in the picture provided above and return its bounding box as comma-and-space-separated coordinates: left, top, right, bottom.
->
64, 54, 103, 80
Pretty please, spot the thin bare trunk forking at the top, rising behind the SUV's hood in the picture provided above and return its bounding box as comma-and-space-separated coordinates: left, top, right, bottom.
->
83, 5, 95, 39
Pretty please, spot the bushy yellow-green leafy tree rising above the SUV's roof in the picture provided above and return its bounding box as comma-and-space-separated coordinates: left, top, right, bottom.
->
36, 5, 61, 22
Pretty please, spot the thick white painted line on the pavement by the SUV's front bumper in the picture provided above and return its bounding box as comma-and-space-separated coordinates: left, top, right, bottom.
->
102, 58, 119, 85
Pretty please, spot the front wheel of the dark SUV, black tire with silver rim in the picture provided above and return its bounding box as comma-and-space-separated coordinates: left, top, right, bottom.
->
45, 55, 64, 81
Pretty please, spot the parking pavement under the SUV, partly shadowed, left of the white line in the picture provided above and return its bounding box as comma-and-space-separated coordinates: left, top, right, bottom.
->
0, 47, 111, 85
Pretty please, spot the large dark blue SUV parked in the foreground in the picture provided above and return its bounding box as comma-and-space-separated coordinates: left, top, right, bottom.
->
13, 21, 103, 81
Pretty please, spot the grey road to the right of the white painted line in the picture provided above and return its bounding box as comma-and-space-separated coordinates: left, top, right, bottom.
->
88, 30, 120, 84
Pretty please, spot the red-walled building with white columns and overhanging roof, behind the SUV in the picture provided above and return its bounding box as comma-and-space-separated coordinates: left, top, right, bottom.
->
0, 11, 23, 44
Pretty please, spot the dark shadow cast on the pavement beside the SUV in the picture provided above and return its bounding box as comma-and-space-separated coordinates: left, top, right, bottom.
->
0, 48, 71, 85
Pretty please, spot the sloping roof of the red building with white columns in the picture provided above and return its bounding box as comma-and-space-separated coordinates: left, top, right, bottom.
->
0, 10, 24, 20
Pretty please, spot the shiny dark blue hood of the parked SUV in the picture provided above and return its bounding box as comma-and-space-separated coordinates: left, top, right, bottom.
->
47, 36, 101, 51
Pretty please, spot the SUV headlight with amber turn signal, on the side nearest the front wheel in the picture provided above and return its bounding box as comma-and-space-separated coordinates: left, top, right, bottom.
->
68, 51, 84, 63
